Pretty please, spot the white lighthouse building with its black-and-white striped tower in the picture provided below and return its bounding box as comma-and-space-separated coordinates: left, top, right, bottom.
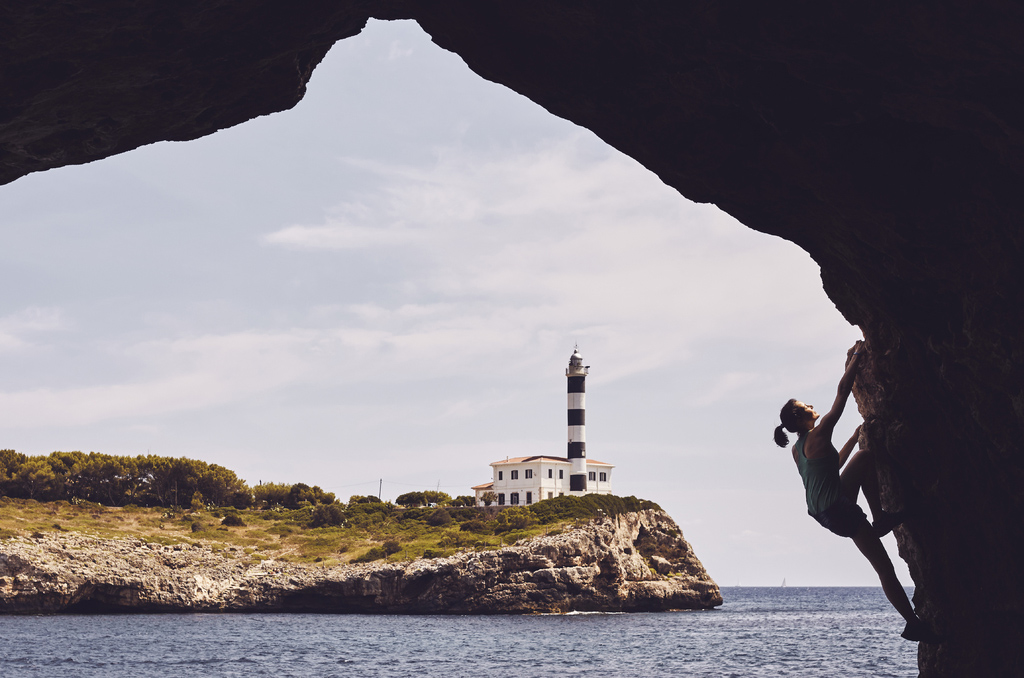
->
472, 348, 614, 506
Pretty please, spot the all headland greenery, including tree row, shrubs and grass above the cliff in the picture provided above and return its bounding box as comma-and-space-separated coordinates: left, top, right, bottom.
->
0, 450, 658, 565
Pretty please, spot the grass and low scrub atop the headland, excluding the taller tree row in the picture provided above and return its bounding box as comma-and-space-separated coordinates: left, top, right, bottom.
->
0, 485, 657, 566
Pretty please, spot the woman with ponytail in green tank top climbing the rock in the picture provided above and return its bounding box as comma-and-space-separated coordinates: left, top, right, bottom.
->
775, 341, 939, 643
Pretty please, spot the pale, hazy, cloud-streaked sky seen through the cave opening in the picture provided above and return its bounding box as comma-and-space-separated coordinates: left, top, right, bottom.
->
0, 20, 912, 586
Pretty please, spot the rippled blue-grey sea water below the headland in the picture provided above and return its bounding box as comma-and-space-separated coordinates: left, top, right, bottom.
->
0, 587, 918, 678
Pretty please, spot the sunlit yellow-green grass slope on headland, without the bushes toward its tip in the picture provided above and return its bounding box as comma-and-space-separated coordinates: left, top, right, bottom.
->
0, 497, 573, 565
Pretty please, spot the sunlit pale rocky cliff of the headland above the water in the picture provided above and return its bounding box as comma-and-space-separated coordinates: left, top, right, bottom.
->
0, 510, 722, 615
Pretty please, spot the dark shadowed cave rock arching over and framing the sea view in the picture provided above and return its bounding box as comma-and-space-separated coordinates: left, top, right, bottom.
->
0, 0, 1024, 676
